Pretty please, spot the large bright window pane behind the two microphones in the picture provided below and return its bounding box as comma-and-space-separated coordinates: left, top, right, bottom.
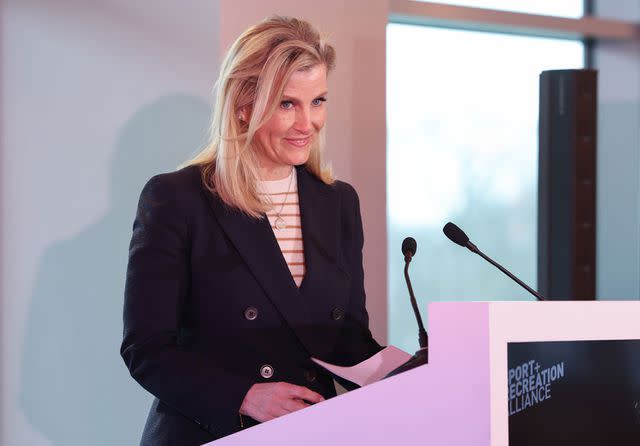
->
387, 24, 584, 351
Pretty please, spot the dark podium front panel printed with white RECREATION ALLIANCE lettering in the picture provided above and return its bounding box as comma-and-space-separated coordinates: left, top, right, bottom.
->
507, 340, 640, 446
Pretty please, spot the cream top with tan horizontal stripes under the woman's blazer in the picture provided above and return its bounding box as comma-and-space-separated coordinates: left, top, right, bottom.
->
258, 169, 306, 286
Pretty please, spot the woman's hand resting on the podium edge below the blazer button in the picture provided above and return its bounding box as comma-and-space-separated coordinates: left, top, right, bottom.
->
240, 382, 324, 422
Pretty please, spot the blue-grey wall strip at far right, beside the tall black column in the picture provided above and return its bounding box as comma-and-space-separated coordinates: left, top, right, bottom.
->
594, 0, 640, 299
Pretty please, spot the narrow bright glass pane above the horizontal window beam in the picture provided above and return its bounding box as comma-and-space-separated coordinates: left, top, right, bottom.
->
425, 0, 584, 18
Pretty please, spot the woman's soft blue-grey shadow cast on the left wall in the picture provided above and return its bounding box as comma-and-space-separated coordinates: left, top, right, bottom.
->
20, 94, 210, 446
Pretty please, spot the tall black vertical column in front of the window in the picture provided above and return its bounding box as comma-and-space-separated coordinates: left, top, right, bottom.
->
538, 70, 597, 300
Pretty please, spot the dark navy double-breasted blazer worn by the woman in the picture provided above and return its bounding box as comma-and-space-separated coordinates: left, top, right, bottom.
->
121, 166, 381, 446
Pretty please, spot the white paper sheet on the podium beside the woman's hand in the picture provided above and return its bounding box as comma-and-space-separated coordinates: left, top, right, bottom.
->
311, 345, 411, 386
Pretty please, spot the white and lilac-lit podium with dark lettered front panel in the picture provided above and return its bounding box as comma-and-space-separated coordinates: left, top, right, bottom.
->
209, 301, 640, 446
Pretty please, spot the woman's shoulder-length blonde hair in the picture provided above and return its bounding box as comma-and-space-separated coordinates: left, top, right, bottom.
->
185, 16, 335, 218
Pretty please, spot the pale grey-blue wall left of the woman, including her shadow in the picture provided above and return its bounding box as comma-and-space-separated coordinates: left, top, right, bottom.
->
0, 0, 219, 446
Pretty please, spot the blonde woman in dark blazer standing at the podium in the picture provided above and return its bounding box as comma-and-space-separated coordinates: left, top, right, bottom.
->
121, 17, 380, 445
